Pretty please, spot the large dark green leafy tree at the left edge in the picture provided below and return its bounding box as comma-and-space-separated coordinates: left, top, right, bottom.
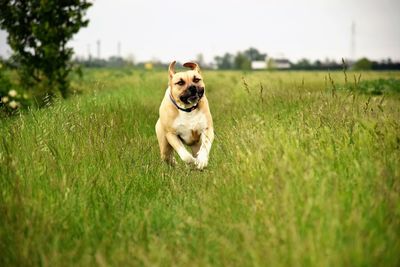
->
0, 0, 91, 100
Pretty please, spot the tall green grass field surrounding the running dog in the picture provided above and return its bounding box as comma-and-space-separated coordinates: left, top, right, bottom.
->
0, 70, 400, 266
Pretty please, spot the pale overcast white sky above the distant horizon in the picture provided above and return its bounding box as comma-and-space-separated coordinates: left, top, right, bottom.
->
0, 0, 400, 62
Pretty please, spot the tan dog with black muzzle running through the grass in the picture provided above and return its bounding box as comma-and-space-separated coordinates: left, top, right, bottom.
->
156, 61, 214, 170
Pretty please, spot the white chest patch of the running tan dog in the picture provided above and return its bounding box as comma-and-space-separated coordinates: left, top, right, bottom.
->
173, 110, 207, 144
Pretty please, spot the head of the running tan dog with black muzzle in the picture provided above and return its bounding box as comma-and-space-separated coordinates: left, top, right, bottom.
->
169, 61, 205, 107
